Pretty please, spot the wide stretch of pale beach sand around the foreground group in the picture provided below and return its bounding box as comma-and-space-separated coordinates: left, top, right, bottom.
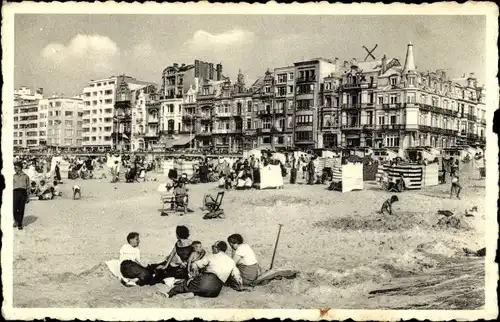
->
14, 165, 485, 309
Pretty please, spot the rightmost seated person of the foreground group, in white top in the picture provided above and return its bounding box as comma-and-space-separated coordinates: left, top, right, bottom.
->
227, 234, 260, 286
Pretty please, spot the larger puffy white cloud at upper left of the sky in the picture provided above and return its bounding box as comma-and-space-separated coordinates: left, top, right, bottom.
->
40, 34, 120, 70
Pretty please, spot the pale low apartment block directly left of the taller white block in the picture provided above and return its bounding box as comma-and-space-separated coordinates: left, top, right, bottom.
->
45, 96, 84, 147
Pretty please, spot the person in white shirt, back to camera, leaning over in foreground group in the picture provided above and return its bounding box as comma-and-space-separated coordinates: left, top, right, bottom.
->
164, 241, 243, 298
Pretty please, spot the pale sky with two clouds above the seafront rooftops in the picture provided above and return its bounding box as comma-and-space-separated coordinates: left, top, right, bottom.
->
14, 14, 486, 95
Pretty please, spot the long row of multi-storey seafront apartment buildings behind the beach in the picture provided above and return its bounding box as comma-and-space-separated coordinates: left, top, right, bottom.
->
14, 44, 486, 151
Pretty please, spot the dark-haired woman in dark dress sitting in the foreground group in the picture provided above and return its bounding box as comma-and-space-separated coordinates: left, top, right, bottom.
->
151, 226, 193, 281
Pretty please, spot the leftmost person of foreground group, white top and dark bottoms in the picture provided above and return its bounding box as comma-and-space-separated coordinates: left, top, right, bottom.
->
120, 232, 153, 286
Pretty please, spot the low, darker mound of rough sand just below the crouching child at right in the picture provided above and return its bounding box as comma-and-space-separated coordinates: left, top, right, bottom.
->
314, 212, 430, 231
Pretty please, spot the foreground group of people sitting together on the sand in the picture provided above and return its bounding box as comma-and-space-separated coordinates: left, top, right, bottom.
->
116, 226, 260, 297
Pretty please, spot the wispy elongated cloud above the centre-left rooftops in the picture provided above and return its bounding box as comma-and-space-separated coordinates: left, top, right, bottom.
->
186, 28, 255, 51
